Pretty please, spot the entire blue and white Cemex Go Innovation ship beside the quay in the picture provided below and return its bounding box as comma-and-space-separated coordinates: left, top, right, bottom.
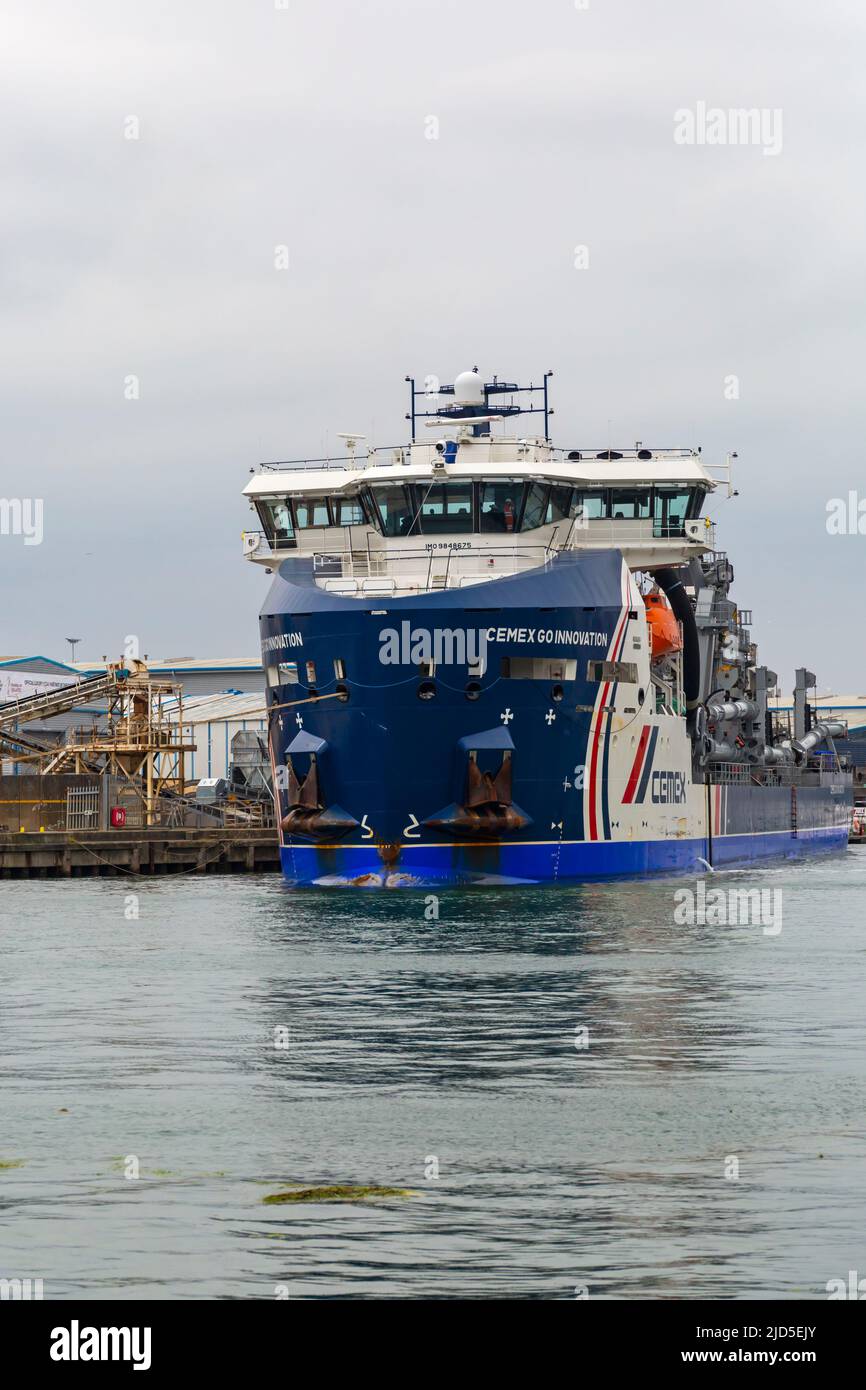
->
243, 370, 851, 887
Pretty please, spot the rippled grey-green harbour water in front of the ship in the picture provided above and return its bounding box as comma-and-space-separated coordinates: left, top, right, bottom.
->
0, 849, 866, 1300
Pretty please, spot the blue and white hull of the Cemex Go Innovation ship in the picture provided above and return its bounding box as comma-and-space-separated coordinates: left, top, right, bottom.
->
261, 550, 849, 887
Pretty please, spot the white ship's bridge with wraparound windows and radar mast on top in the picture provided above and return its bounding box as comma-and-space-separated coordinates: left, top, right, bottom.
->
243, 371, 716, 598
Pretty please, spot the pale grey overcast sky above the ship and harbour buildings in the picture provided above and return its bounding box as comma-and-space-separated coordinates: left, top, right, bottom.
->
0, 0, 866, 692
